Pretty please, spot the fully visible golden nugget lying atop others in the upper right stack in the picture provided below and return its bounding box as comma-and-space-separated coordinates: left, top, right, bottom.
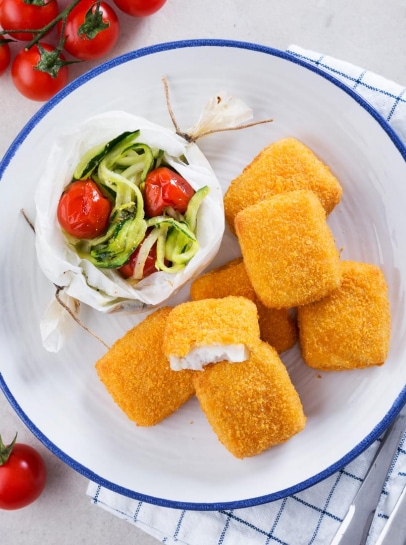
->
235, 190, 340, 308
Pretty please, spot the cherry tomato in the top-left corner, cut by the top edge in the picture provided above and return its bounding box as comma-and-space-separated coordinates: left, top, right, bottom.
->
0, 0, 58, 41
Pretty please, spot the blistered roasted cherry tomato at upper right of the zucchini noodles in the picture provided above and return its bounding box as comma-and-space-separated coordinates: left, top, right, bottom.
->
144, 167, 195, 218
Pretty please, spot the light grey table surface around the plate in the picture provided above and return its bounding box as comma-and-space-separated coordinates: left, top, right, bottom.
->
0, 0, 406, 545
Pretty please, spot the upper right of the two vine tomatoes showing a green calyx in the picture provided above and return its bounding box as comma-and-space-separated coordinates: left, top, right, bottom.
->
58, 0, 120, 61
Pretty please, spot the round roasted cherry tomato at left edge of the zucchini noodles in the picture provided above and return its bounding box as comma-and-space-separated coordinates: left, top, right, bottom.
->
57, 179, 111, 238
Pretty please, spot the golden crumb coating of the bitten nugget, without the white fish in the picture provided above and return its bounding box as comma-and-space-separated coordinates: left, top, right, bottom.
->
163, 296, 259, 357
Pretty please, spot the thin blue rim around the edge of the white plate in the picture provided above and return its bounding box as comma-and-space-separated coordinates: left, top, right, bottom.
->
0, 39, 406, 511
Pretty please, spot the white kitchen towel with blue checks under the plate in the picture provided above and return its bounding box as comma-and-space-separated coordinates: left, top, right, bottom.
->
87, 46, 406, 545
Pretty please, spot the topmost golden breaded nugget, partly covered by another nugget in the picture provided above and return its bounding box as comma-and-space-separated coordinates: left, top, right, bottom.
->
224, 138, 342, 232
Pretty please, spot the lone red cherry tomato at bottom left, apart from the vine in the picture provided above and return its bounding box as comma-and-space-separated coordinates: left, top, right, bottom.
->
0, 438, 47, 510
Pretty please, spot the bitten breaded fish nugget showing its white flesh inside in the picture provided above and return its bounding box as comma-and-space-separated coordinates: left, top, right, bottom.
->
163, 296, 259, 371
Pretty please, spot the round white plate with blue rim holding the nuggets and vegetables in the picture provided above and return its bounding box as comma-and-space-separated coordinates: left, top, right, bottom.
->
0, 41, 406, 509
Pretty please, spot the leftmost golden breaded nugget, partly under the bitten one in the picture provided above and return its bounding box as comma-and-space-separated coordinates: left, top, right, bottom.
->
96, 307, 194, 426
